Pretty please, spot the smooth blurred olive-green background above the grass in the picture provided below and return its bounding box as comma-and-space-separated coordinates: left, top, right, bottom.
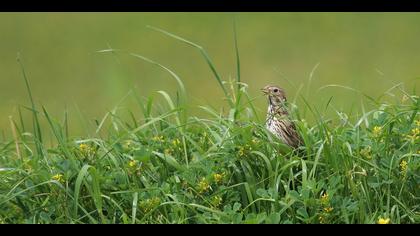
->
0, 13, 420, 134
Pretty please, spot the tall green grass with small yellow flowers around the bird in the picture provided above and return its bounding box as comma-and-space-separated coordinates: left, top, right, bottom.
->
0, 28, 420, 224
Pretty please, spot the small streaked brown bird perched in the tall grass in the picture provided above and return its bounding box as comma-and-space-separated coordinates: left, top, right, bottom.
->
261, 85, 303, 148
